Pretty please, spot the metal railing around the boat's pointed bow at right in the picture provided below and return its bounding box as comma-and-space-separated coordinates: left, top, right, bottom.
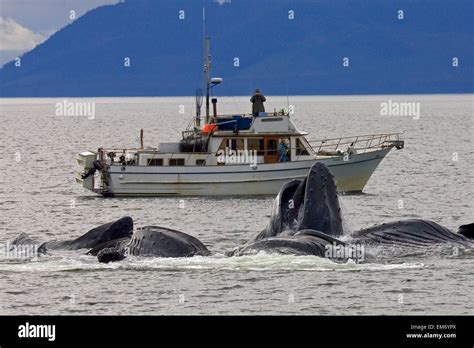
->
308, 133, 404, 156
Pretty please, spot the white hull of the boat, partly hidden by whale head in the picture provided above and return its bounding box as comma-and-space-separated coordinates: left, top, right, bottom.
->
96, 148, 390, 197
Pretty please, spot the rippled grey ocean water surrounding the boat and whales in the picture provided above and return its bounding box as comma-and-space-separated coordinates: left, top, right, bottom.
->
0, 95, 474, 315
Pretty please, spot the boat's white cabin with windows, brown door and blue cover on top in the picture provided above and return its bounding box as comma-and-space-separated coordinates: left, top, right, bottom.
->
105, 112, 315, 166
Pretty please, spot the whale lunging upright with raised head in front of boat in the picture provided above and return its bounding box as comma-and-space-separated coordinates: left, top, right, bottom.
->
228, 162, 345, 257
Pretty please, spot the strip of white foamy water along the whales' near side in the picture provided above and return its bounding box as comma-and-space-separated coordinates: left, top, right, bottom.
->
0, 252, 424, 272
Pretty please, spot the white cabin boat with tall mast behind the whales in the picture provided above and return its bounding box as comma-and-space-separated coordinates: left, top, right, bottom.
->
77, 38, 404, 197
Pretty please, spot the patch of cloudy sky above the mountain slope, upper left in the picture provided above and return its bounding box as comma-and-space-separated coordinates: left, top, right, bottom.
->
0, 0, 119, 65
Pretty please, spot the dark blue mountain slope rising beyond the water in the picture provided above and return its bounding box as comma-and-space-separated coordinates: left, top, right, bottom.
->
0, 0, 474, 97
